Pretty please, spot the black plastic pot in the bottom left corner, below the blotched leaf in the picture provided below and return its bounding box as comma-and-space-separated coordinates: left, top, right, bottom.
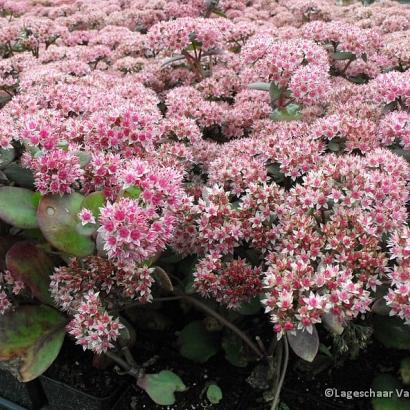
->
0, 370, 46, 410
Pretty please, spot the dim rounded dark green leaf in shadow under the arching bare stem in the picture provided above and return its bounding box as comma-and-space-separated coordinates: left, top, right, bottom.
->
178, 320, 218, 363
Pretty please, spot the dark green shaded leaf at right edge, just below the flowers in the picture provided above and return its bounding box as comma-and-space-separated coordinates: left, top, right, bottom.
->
373, 315, 410, 350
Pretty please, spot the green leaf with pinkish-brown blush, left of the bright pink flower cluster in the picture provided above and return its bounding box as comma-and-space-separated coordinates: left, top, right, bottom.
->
37, 192, 95, 256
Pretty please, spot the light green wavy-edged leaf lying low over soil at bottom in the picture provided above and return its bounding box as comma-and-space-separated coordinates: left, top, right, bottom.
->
137, 370, 186, 406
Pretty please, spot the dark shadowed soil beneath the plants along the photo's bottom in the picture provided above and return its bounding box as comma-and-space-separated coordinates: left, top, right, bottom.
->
40, 303, 408, 410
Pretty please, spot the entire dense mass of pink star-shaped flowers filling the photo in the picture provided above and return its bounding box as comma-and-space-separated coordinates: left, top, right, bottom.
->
0, 0, 410, 353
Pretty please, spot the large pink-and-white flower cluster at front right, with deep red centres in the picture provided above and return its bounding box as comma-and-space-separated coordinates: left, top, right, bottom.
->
264, 150, 409, 335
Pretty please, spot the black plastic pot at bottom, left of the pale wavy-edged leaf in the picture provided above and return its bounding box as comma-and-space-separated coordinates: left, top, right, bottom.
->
40, 376, 123, 410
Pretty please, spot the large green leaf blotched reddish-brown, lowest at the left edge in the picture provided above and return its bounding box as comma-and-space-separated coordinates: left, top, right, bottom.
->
0, 305, 66, 382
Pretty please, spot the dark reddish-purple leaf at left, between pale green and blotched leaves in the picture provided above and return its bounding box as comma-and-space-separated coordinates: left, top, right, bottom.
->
6, 242, 54, 304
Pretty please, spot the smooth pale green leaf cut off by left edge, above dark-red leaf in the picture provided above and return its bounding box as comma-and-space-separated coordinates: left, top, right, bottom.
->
0, 186, 38, 229
